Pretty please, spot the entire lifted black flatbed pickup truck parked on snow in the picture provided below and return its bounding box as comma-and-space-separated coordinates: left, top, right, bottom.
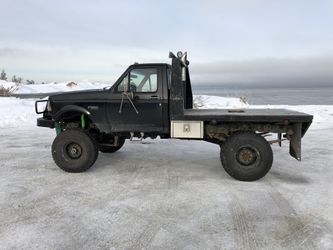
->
35, 52, 313, 181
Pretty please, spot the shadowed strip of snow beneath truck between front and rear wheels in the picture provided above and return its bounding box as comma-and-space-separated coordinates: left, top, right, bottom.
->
89, 143, 230, 179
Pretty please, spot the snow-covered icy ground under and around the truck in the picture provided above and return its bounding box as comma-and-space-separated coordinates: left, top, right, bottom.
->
0, 96, 333, 249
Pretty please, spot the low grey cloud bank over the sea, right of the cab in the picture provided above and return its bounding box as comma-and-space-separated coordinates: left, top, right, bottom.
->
191, 56, 333, 87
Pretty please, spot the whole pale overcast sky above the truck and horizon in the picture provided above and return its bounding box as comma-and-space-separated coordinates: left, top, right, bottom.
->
0, 0, 333, 86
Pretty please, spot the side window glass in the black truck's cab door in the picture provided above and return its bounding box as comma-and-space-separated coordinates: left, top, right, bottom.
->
130, 68, 157, 93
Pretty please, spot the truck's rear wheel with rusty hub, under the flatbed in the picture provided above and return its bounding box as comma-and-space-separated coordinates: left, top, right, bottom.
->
220, 133, 273, 181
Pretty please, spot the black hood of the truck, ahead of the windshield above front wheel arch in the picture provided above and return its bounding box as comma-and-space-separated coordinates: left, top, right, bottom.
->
49, 89, 109, 102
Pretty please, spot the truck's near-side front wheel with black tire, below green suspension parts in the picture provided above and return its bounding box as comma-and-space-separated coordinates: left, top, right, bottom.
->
52, 130, 98, 173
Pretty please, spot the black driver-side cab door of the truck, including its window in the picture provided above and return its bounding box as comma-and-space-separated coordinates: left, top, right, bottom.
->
107, 66, 163, 133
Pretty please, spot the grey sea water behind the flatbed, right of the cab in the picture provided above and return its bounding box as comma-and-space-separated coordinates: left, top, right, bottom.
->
192, 85, 333, 105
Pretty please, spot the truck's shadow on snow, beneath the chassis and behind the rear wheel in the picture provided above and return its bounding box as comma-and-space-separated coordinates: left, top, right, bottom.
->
89, 143, 311, 185
